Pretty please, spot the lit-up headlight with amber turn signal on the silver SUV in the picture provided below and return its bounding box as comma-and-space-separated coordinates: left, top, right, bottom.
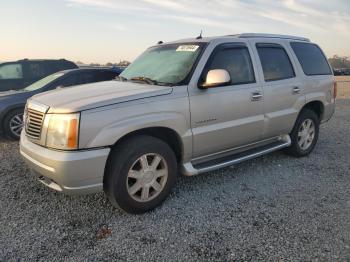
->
46, 114, 80, 150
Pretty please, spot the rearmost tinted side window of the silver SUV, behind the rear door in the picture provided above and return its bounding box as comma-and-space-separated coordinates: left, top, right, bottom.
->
290, 42, 332, 76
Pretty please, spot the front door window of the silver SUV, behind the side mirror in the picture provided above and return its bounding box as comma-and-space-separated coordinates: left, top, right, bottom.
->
203, 47, 255, 85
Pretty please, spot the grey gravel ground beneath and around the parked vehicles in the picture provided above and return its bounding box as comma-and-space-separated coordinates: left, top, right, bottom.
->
0, 87, 350, 261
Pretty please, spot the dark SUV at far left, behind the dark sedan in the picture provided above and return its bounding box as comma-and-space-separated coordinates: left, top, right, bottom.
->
0, 59, 78, 92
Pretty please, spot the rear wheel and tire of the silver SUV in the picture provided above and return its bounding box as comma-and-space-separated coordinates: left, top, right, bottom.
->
285, 109, 320, 157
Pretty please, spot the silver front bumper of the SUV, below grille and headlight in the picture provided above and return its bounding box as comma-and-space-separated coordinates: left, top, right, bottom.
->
20, 132, 110, 194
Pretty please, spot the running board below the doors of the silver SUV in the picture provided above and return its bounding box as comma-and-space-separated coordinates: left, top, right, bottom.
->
182, 135, 291, 176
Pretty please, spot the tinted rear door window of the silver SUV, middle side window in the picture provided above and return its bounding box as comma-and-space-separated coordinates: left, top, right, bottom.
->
256, 44, 295, 82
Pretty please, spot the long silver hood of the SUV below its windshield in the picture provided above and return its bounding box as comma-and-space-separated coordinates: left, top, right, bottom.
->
31, 80, 173, 113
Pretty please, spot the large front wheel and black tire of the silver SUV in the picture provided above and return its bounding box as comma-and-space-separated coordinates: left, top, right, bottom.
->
103, 135, 177, 214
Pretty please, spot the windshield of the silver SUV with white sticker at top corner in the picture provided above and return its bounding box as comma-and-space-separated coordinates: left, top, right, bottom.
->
120, 43, 203, 85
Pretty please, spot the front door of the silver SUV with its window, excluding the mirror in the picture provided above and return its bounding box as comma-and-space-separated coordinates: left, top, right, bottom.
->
189, 43, 264, 158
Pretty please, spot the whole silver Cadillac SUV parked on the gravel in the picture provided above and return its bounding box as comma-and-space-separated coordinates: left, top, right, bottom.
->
20, 34, 336, 213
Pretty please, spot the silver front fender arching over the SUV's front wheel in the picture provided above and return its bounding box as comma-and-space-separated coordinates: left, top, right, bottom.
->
79, 96, 192, 159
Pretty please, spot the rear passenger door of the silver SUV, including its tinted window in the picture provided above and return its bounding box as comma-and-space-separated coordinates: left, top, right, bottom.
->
252, 41, 305, 139
